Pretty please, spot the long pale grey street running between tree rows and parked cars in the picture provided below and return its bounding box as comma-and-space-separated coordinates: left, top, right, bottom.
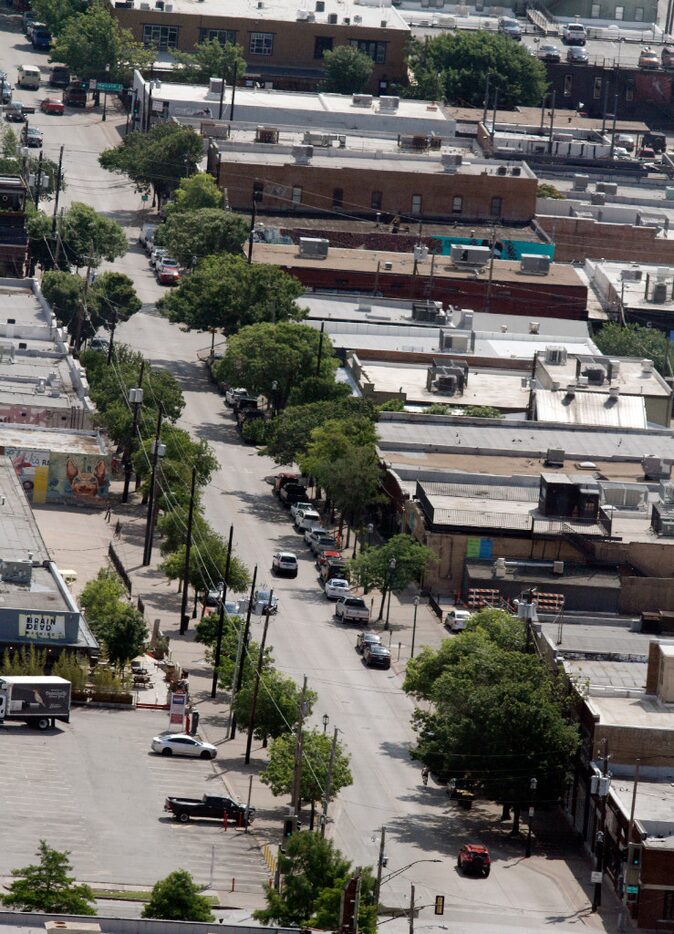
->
0, 25, 624, 934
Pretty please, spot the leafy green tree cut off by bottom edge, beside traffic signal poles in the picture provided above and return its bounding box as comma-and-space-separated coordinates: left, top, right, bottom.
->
253, 833, 377, 934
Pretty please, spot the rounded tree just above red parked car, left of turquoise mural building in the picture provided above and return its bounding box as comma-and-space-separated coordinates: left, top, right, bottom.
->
154, 208, 248, 267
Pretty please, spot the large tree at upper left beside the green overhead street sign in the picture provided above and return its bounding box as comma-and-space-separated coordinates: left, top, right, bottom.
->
52, 2, 154, 83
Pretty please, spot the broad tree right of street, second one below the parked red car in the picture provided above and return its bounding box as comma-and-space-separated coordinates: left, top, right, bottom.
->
213, 321, 337, 409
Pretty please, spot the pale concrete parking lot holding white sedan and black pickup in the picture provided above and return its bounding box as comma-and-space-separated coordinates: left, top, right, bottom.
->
0, 708, 268, 892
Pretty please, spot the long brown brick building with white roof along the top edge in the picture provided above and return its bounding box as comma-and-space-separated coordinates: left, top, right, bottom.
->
111, 0, 410, 93
